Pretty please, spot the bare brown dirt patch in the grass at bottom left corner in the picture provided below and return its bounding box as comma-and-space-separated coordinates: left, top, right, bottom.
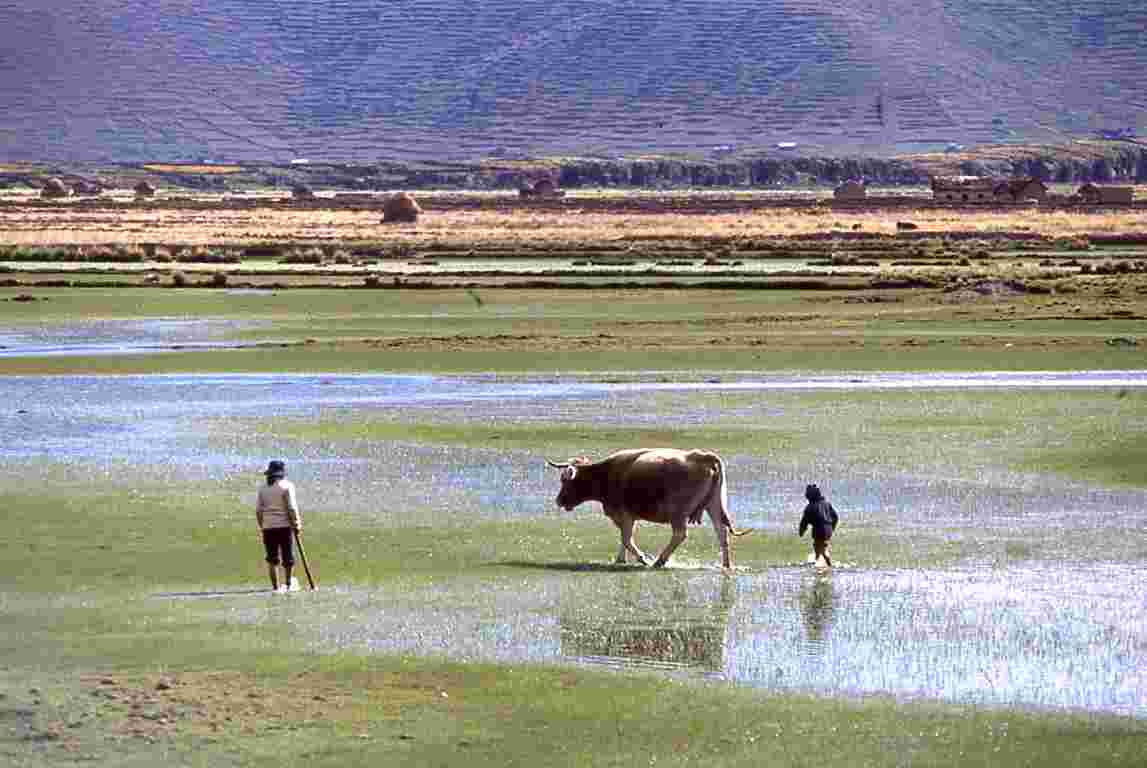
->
0, 671, 450, 760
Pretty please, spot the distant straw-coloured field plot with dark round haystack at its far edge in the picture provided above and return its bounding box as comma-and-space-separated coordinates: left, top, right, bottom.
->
0, 193, 1147, 246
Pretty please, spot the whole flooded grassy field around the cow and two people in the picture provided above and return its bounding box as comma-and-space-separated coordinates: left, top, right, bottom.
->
8, 371, 1147, 718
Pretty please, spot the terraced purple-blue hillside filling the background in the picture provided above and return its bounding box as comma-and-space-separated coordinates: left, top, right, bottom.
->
0, 0, 1147, 162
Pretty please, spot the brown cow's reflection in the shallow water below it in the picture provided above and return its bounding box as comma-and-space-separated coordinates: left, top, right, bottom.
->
561, 575, 735, 672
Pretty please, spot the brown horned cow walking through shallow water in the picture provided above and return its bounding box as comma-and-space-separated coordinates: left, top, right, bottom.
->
547, 448, 748, 569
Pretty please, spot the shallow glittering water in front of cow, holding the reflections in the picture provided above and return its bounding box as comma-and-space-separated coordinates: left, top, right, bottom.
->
208, 561, 1147, 718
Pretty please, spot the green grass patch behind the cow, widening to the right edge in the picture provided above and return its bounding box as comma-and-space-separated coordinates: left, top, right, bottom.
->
232, 389, 1147, 487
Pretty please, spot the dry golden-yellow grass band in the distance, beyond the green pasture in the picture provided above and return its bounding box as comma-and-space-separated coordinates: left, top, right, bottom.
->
0, 202, 1147, 248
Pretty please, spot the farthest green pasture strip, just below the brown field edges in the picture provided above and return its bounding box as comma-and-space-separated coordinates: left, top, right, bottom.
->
0, 287, 1137, 338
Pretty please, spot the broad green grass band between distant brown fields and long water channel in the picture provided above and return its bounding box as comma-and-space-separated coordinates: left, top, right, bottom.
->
0, 288, 1147, 375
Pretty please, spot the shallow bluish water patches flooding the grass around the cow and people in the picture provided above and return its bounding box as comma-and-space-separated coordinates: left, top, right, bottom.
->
0, 371, 1147, 718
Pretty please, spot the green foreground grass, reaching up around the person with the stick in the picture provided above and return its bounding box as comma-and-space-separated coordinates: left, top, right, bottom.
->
0, 472, 1147, 768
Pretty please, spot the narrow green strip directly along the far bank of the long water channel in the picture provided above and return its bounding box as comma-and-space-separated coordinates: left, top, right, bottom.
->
0, 339, 1147, 377
